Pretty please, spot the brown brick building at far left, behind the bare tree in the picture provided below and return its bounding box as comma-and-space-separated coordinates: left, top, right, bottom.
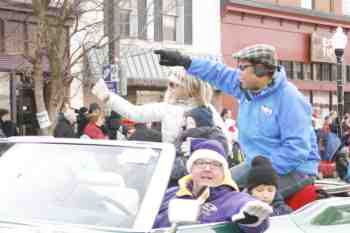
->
0, 0, 69, 134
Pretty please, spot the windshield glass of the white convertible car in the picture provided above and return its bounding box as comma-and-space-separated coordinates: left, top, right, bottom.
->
0, 143, 160, 228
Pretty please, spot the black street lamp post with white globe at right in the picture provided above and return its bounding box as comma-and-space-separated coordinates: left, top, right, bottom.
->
332, 27, 348, 137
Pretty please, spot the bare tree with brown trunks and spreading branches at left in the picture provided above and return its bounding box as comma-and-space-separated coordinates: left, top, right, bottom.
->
5, 0, 176, 135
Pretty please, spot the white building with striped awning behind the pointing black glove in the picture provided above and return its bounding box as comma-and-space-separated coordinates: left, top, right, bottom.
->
83, 0, 221, 106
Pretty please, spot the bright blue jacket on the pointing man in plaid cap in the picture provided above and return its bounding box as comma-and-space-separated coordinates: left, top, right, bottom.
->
187, 59, 320, 175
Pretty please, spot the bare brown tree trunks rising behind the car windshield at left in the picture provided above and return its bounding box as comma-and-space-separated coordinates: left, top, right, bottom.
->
1, 0, 105, 135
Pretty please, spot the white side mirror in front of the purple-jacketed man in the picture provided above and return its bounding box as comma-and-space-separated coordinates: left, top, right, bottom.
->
168, 199, 201, 224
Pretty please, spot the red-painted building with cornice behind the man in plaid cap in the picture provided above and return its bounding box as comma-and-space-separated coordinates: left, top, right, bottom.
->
221, 0, 350, 118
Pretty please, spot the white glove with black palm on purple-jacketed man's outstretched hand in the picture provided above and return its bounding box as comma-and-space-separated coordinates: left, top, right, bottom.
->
231, 200, 273, 227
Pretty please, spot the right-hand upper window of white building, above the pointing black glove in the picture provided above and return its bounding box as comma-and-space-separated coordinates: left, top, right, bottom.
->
154, 0, 177, 41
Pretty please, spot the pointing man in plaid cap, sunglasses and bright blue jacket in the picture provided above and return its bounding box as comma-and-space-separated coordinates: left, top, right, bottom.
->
155, 44, 320, 198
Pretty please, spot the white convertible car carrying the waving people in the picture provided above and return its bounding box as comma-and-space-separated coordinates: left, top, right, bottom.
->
0, 137, 350, 233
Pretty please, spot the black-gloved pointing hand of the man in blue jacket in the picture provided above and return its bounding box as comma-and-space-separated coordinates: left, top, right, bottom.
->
154, 49, 192, 69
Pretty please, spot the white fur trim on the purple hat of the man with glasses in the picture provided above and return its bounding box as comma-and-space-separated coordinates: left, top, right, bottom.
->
186, 149, 228, 173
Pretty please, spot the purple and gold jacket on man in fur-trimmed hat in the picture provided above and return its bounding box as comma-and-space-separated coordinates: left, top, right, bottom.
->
153, 175, 269, 233
